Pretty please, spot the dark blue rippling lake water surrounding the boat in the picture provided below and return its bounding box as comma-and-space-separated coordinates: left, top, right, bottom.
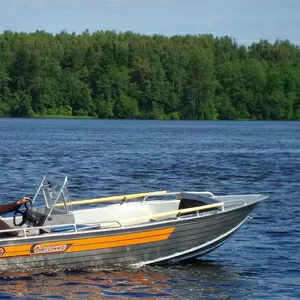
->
0, 119, 300, 299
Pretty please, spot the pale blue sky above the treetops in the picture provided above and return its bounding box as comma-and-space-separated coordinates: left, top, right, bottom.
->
0, 0, 300, 45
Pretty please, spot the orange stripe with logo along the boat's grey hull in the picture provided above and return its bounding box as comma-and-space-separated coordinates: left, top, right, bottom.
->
0, 227, 175, 258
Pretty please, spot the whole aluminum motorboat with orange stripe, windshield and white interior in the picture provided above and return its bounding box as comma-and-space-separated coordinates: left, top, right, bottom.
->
0, 173, 267, 270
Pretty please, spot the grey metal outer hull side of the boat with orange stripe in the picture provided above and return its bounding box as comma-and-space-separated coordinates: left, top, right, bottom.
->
0, 203, 257, 270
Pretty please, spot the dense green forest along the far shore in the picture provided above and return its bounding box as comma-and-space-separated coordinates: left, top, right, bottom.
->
0, 31, 300, 120
